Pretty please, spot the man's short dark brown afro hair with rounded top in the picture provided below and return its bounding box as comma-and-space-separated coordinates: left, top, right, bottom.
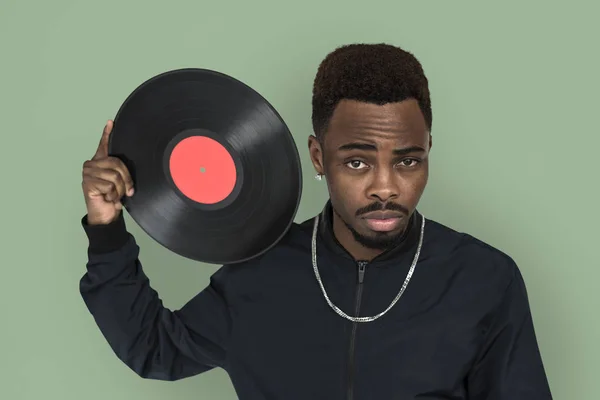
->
312, 43, 432, 138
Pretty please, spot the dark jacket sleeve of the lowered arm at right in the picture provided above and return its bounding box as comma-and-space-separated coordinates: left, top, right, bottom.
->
467, 263, 552, 400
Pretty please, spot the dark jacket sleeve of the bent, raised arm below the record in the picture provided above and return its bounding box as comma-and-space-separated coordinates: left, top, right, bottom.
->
80, 215, 230, 381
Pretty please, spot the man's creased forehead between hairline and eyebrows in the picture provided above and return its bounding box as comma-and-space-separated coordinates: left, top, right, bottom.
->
325, 99, 429, 145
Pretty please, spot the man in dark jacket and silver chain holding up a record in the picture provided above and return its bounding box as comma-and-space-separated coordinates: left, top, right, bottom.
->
81, 44, 552, 400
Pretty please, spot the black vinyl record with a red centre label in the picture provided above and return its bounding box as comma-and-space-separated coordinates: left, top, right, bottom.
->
109, 69, 302, 264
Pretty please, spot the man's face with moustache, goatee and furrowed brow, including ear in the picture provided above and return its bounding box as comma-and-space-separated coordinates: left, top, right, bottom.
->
309, 100, 431, 249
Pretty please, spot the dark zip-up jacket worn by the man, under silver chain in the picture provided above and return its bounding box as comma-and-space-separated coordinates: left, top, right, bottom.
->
80, 203, 552, 400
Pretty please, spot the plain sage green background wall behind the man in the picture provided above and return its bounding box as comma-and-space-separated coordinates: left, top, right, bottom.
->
0, 0, 600, 400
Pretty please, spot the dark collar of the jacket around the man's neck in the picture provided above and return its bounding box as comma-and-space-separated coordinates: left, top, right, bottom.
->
319, 200, 423, 264
